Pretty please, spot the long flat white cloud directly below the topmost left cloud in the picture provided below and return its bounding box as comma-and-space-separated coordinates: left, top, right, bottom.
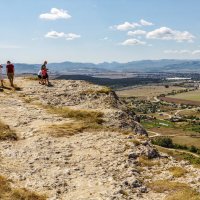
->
45, 31, 81, 40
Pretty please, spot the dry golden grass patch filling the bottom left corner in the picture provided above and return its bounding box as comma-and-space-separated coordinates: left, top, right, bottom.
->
0, 176, 47, 200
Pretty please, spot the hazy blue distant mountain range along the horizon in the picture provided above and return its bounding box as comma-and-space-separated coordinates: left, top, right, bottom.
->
3, 59, 200, 74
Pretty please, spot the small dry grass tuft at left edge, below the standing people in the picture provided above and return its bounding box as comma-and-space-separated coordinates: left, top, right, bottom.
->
0, 122, 17, 140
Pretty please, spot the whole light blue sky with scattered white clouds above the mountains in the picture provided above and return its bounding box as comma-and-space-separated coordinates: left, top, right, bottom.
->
0, 0, 200, 63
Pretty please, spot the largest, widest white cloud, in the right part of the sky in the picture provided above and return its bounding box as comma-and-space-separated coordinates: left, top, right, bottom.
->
146, 27, 195, 42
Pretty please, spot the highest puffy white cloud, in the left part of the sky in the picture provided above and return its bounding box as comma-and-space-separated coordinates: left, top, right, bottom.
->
40, 8, 71, 20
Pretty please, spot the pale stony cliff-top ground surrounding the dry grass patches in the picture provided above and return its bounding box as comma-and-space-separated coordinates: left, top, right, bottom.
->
0, 78, 200, 200
